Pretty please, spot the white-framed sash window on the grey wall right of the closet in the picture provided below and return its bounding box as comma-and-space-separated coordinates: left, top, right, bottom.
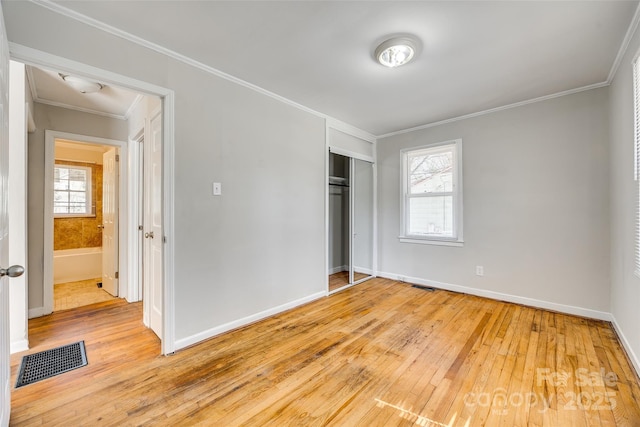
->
400, 140, 463, 246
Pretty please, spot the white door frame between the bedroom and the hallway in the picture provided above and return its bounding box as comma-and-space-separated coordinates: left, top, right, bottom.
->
9, 42, 176, 354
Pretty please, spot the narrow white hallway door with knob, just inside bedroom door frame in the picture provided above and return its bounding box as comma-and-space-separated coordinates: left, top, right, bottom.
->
143, 114, 163, 338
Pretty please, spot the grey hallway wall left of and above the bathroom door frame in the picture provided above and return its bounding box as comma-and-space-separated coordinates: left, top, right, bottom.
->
27, 103, 127, 312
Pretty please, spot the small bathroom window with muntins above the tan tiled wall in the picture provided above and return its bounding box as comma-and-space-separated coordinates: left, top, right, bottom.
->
53, 165, 93, 217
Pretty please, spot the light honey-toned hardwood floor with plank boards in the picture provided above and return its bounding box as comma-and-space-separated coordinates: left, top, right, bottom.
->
11, 279, 640, 427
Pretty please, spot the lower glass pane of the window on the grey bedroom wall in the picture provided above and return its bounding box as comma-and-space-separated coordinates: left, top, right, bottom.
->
408, 196, 453, 237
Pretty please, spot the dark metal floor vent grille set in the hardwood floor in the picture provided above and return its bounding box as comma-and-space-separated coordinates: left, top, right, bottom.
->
16, 341, 88, 388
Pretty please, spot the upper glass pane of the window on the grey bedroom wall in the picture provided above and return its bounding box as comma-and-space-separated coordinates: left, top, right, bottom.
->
408, 150, 453, 194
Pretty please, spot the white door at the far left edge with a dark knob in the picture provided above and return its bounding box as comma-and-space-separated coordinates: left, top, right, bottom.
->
0, 3, 15, 427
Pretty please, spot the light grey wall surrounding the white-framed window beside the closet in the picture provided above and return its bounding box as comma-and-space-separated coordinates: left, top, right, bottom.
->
377, 88, 610, 318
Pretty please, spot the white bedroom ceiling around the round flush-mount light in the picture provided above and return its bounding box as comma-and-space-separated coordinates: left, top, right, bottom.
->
42, 0, 638, 135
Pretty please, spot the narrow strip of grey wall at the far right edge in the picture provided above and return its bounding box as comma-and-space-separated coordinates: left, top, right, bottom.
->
609, 22, 640, 372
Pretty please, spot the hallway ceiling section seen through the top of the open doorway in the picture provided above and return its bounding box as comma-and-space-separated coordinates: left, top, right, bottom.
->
27, 66, 142, 120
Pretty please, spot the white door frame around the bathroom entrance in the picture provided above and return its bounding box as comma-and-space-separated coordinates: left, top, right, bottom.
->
42, 129, 126, 315
